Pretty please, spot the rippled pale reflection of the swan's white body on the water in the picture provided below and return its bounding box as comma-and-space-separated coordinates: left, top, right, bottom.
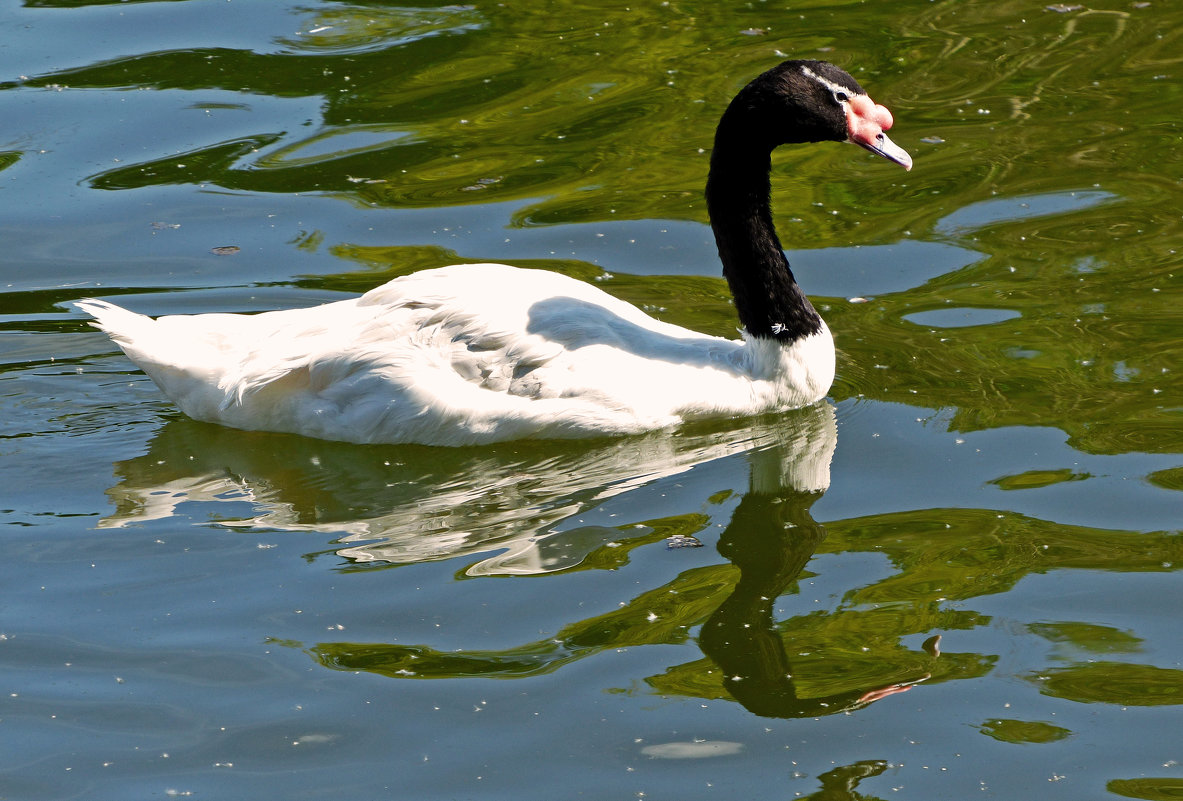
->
99, 405, 836, 567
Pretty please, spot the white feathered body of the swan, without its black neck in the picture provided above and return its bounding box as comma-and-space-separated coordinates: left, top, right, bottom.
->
77, 264, 834, 445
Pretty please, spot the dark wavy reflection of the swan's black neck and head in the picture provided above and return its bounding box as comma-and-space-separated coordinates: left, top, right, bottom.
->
699, 490, 865, 717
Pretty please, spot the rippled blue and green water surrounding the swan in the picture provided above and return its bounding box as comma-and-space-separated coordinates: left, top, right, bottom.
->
0, 0, 1183, 800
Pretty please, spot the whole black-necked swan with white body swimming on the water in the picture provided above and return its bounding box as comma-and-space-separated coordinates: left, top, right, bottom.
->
75, 60, 912, 446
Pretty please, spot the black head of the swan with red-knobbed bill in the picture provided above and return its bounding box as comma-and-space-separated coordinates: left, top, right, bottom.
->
716, 60, 912, 169
